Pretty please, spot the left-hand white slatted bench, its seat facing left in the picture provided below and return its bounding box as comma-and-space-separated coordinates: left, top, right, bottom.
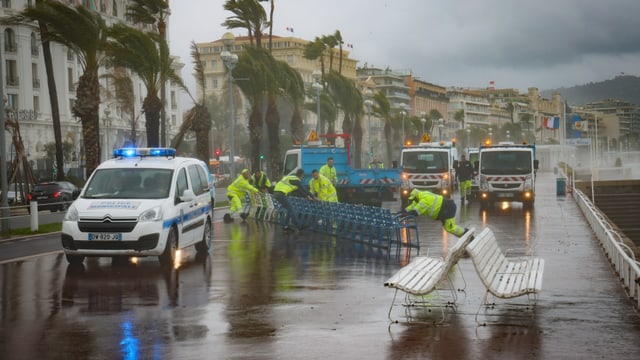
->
384, 229, 474, 321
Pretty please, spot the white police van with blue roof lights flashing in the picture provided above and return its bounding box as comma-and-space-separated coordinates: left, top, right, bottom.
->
61, 148, 214, 265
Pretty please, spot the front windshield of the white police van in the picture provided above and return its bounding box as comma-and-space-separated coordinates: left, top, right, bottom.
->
83, 169, 173, 199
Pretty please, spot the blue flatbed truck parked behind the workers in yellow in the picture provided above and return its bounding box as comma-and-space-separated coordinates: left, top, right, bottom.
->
282, 135, 402, 206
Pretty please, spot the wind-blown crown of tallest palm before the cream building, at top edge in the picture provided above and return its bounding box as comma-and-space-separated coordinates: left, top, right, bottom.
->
222, 0, 269, 48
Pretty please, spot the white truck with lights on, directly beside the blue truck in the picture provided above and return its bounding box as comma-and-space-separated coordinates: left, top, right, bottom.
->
400, 141, 458, 208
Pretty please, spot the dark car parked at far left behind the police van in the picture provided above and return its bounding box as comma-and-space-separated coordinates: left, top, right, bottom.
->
29, 181, 80, 211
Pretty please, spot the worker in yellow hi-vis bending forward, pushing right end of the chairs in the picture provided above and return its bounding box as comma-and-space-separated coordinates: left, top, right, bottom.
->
405, 189, 467, 237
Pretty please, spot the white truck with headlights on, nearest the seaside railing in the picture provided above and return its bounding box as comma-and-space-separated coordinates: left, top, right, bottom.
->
478, 143, 538, 209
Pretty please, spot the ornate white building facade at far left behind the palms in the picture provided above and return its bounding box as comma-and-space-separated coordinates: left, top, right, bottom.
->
0, 0, 183, 180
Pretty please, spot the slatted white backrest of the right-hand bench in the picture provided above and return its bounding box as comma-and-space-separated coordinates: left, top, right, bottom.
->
467, 228, 507, 288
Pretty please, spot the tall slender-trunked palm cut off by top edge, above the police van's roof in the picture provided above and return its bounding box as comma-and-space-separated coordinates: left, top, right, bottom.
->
127, 0, 170, 146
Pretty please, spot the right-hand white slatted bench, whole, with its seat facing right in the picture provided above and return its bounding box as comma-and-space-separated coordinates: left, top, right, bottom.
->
466, 228, 544, 321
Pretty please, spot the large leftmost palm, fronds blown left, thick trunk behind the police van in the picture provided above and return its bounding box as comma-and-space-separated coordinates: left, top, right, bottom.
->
3, 0, 107, 174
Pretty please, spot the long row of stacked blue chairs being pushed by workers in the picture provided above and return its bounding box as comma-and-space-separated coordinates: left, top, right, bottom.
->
245, 194, 420, 254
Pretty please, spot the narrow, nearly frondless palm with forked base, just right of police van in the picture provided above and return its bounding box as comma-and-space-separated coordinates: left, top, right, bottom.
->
171, 42, 211, 164
